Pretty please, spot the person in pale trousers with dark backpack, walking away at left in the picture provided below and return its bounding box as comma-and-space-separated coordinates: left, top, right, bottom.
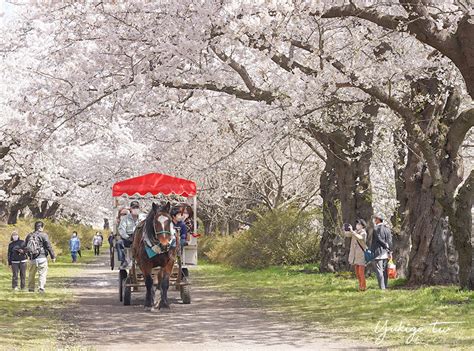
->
25, 221, 56, 293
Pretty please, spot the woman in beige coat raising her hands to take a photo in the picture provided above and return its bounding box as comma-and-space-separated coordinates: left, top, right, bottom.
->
344, 219, 367, 291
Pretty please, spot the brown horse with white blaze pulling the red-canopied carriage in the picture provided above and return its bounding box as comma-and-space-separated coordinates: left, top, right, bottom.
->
132, 202, 179, 310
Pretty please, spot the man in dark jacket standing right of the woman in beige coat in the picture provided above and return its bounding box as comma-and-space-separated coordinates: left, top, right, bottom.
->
371, 213, 392, 290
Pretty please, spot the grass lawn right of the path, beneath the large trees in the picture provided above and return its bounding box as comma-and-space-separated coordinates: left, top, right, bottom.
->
196, 262, 474, 350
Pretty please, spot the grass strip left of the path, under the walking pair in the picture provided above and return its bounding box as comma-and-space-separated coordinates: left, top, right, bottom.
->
0, 250, 94, 350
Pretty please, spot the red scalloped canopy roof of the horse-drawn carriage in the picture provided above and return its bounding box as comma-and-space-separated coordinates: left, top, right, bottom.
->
112, 173, 196, 197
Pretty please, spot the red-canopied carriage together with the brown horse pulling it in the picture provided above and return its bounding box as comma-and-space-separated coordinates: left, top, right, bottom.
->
110, 173, 197, 308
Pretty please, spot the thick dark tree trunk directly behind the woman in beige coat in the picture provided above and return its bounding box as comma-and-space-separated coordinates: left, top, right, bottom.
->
313, 104, 379, 272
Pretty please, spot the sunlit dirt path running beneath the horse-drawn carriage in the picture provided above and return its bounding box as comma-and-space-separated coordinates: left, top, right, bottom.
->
66, 256, 378, 351
